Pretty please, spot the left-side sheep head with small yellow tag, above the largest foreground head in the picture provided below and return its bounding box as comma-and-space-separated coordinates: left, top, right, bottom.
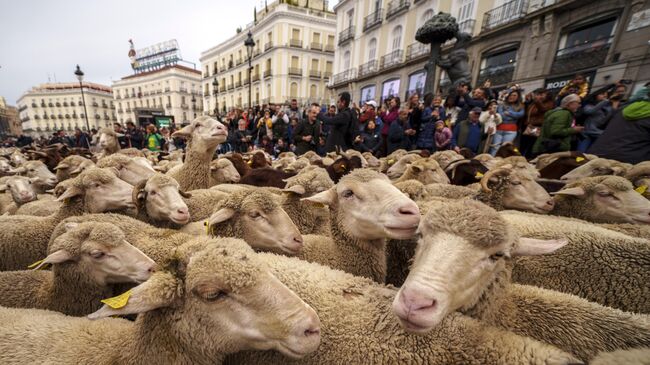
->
42, 222, 156, 285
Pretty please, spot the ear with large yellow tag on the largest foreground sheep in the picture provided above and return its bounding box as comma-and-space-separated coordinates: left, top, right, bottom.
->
88, 271, 181, 319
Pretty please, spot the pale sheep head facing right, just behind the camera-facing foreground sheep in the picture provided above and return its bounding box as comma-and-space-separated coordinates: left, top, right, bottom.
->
304, 170, 420, 240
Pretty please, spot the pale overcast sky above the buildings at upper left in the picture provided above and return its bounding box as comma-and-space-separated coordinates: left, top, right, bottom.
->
0, 0, 338, 105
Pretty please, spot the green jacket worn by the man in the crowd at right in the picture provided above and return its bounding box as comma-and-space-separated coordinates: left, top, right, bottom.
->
533, 108, 578, 153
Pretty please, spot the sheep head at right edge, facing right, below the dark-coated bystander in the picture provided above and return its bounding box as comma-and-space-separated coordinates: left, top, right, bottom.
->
552, 175, 650, 224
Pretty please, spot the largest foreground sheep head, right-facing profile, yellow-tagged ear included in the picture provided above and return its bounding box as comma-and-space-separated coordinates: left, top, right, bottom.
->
89, 239, 320, 361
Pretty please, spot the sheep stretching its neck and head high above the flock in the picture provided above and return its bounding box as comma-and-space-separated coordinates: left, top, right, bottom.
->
167, 116, 228, 191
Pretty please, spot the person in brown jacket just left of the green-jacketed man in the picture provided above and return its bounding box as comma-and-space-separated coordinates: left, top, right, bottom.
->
519, 89, 555, 158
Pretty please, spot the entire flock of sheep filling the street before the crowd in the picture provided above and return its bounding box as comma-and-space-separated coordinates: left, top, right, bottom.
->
0, 117, 650, 364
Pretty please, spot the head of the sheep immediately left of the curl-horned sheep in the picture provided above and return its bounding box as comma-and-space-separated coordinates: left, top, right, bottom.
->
57, 167, 135, 213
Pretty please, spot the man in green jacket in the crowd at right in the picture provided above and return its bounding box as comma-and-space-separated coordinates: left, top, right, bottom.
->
533, 94, 584, 155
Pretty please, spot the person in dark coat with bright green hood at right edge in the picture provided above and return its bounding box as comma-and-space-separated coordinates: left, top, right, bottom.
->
588, 83, 650, 164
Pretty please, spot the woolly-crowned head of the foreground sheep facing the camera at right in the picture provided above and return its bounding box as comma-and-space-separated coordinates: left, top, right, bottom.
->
393, 201, 567, 333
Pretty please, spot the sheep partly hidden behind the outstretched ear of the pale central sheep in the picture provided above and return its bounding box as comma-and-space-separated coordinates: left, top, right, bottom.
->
282, 168, 334, 236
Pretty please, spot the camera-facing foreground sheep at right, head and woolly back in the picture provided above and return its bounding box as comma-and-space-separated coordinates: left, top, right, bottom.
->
393, 200, 650, 361
